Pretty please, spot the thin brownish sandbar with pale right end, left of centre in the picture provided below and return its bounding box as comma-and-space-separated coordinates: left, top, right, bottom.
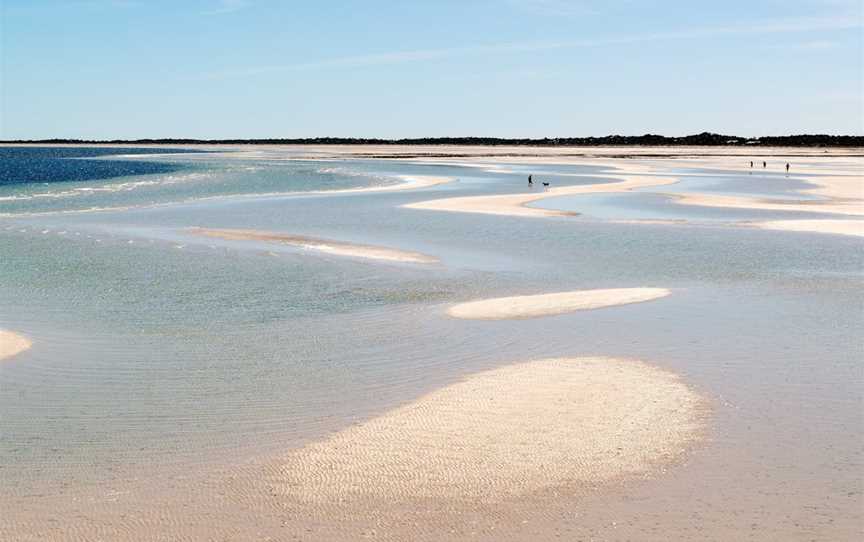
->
187, 228, 438, 263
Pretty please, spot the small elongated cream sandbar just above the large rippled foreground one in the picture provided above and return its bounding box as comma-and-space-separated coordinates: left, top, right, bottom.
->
447, 288, 670, 320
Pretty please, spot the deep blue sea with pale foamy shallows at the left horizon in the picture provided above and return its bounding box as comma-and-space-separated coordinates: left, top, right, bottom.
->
0, 148, 400, 216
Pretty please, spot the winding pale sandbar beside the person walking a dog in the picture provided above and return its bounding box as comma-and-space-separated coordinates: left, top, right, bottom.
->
403, 174, 678, 218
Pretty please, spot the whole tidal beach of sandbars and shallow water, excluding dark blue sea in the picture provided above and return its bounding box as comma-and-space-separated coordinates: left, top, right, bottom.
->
0, 145, 864, 541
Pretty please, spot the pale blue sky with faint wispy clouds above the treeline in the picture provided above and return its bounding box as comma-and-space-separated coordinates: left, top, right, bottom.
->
0, 0, 864, 139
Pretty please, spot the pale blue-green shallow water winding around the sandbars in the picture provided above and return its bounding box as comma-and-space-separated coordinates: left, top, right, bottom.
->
0, 148, 864, 539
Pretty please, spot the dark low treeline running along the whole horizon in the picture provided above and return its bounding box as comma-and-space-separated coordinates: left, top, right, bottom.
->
0, 132, 864, 147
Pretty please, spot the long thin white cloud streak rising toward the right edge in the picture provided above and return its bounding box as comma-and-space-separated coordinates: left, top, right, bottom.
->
205, 16, 862, 79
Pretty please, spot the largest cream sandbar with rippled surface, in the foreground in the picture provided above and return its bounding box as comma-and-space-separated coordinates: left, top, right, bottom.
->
267, 358, 704, 506
